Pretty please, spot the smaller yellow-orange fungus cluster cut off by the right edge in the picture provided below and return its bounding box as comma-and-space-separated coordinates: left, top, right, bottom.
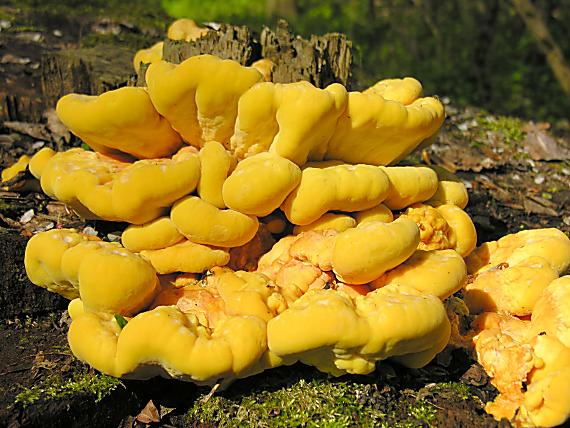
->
450, 229, 570, 426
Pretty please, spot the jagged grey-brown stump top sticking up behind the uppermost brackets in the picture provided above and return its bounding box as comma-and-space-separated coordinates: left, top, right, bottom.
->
149, 21, 352, 88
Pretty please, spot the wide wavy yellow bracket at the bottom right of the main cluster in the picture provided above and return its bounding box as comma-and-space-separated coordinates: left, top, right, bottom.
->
267, 286, 450, 376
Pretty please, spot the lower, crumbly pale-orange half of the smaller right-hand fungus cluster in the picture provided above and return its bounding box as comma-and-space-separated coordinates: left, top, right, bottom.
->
474, 314, 570, 427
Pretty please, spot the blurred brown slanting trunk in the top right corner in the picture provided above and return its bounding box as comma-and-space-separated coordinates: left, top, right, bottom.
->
513, 0, 570, 97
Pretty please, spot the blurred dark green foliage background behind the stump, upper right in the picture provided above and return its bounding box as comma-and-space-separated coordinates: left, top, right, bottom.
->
162, 0, 570, 121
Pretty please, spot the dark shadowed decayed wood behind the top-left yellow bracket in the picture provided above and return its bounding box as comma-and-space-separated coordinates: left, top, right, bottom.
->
41, 45, 133, 108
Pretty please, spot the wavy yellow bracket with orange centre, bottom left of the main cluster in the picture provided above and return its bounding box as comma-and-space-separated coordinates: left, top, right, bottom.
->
69, 269, 284, 384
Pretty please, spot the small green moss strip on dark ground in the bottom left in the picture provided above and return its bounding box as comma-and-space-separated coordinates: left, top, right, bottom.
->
15, 372, 124, 407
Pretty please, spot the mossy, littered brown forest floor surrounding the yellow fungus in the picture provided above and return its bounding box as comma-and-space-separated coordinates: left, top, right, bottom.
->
0, 2, 570, 427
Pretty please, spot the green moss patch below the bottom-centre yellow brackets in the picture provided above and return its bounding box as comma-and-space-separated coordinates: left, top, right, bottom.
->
186, 378, 437, 428
